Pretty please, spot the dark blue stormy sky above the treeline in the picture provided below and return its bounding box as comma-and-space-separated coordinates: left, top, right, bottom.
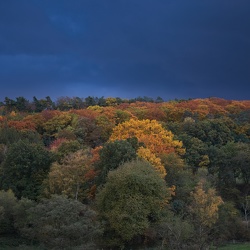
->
0, 0, 250, 100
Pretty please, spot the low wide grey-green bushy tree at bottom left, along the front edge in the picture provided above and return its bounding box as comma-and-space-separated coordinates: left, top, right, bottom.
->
21, 196, 101, 249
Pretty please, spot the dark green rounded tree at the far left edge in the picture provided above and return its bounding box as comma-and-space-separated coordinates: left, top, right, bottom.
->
1, 140, 52, 199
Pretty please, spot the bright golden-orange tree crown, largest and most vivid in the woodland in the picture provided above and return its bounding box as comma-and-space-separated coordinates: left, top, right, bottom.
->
109, 119, 185, 178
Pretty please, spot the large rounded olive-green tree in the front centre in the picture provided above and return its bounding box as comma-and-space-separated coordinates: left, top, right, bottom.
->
96, 160, 170, 246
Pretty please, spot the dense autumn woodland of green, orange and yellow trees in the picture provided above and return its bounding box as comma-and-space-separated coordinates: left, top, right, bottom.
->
0, 96, 250, 250
